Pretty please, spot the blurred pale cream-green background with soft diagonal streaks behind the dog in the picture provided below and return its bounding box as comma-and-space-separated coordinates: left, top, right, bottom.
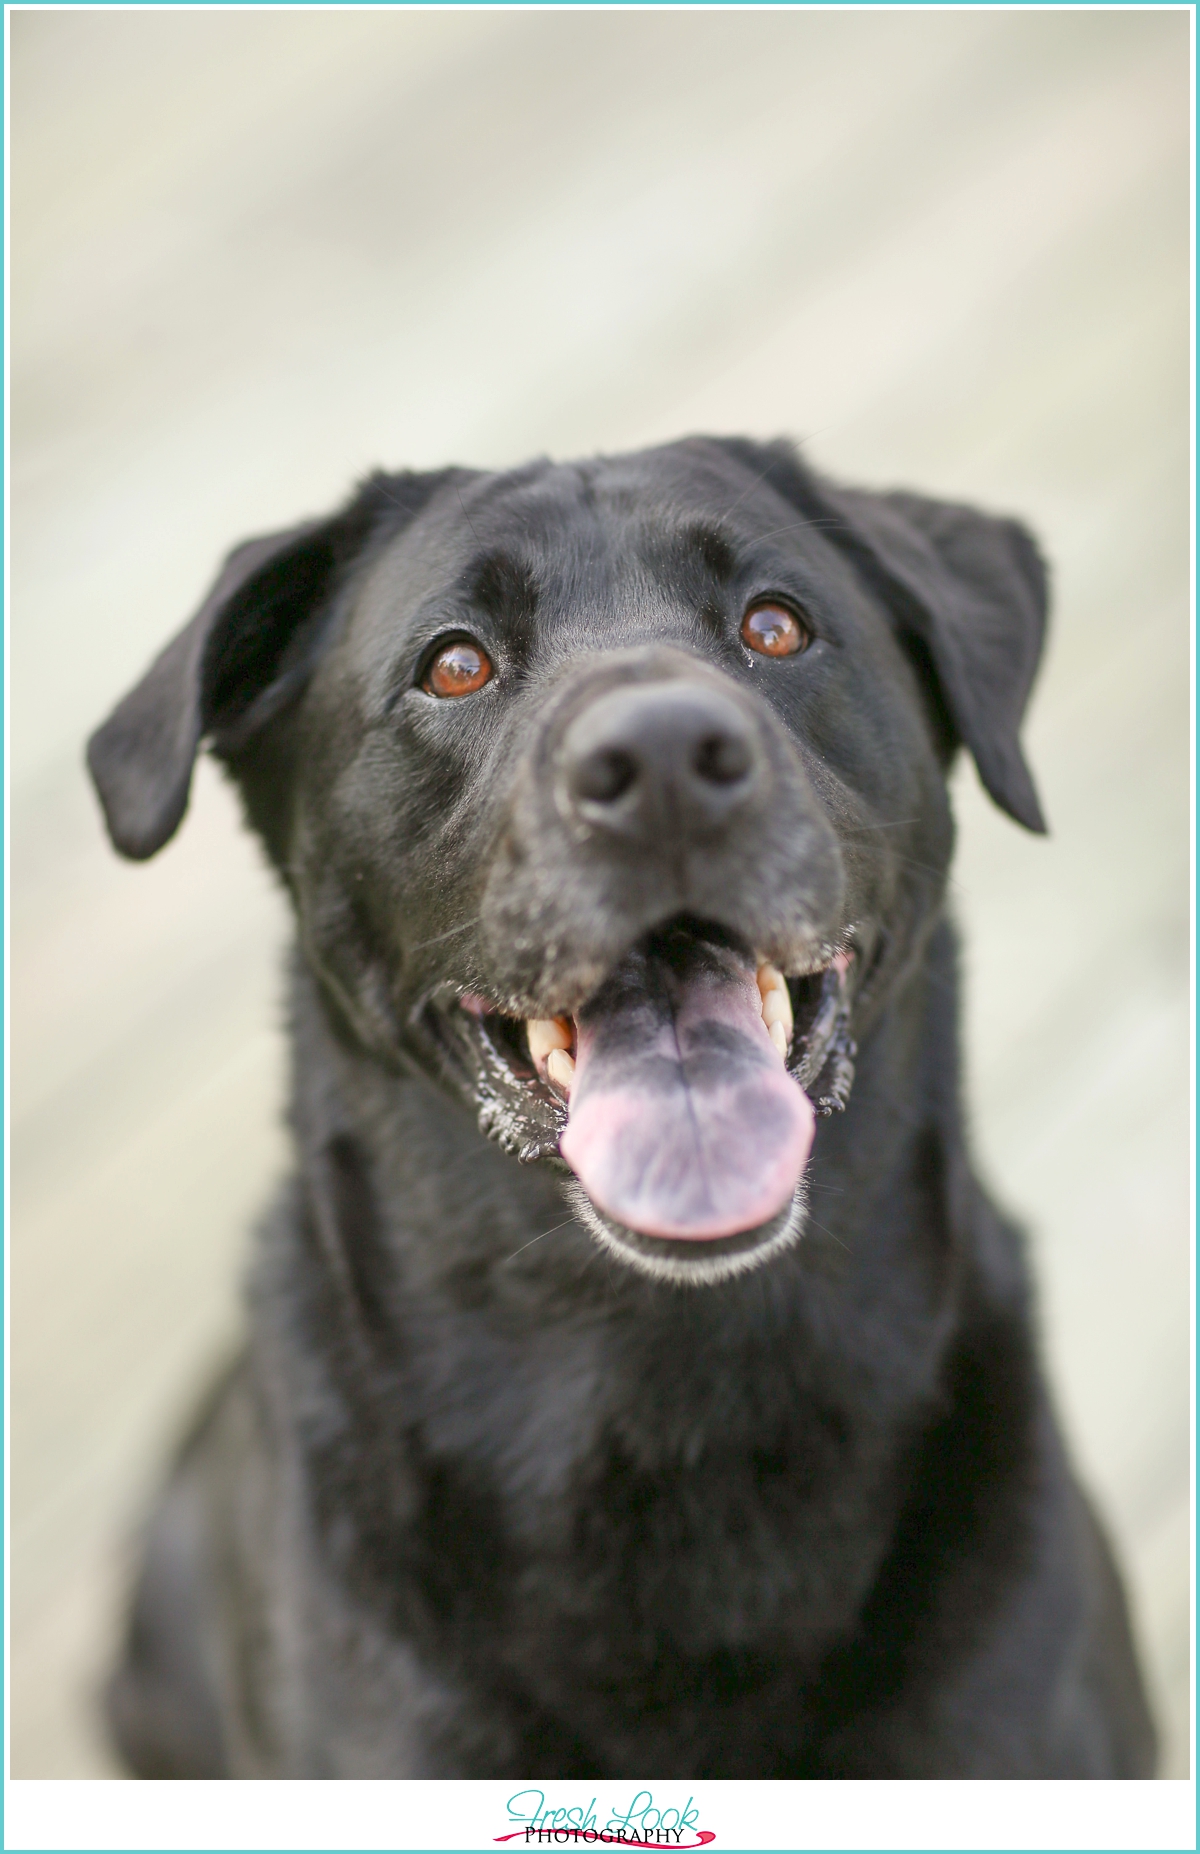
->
9, 7, 1191, 1776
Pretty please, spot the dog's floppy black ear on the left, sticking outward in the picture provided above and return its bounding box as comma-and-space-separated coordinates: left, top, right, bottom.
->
87, 471, 454, 860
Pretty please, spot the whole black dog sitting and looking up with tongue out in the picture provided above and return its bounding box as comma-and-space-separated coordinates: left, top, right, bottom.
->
91, 439, 1154, 1778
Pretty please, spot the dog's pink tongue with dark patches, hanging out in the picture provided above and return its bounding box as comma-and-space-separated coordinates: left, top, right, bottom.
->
560, 936, 814, 1242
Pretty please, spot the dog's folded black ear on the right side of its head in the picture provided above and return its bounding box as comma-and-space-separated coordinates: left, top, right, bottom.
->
719, 443, 1048, 831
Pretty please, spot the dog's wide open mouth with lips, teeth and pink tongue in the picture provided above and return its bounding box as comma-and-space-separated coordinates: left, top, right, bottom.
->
422, 918, 855, 1279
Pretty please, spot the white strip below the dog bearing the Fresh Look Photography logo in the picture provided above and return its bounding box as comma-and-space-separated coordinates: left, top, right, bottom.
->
4, 1778, 1196, 1854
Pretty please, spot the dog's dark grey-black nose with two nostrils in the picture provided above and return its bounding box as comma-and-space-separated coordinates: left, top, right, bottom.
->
560, 680, 762, 836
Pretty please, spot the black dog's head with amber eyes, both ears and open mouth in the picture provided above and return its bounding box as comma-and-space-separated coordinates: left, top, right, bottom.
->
89, 439, 1046, 1281
